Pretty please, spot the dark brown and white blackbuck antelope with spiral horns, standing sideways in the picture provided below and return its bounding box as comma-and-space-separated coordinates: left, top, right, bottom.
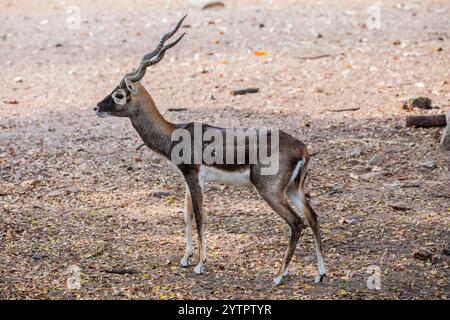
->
94, 17, 325, 284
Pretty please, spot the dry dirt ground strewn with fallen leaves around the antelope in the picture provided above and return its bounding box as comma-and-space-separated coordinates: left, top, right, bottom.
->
0, 0, 450, 299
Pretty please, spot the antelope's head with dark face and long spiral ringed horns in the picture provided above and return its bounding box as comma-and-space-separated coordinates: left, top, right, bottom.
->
94, 16, 186, 117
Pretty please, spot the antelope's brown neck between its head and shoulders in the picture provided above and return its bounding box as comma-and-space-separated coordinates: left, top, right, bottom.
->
130, 92, 175, 157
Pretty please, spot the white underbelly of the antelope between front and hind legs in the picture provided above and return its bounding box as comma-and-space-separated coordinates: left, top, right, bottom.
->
200, 165, 251, 186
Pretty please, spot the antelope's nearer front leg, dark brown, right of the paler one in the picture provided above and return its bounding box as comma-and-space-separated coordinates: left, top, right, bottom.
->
185, 171, 206, 274
